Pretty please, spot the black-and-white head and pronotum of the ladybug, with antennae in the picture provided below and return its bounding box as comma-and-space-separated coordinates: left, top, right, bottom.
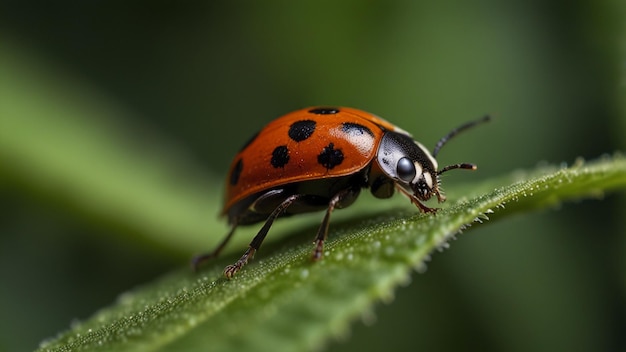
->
372, 116, 489, 211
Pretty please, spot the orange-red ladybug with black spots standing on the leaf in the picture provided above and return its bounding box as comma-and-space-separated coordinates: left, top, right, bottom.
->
192, 107, 489, 279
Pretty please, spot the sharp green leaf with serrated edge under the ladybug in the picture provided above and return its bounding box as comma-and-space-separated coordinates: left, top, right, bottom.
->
40, 155, 626, 351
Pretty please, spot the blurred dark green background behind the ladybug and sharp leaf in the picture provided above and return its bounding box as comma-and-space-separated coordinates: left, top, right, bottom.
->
0, 0, 626, 351
